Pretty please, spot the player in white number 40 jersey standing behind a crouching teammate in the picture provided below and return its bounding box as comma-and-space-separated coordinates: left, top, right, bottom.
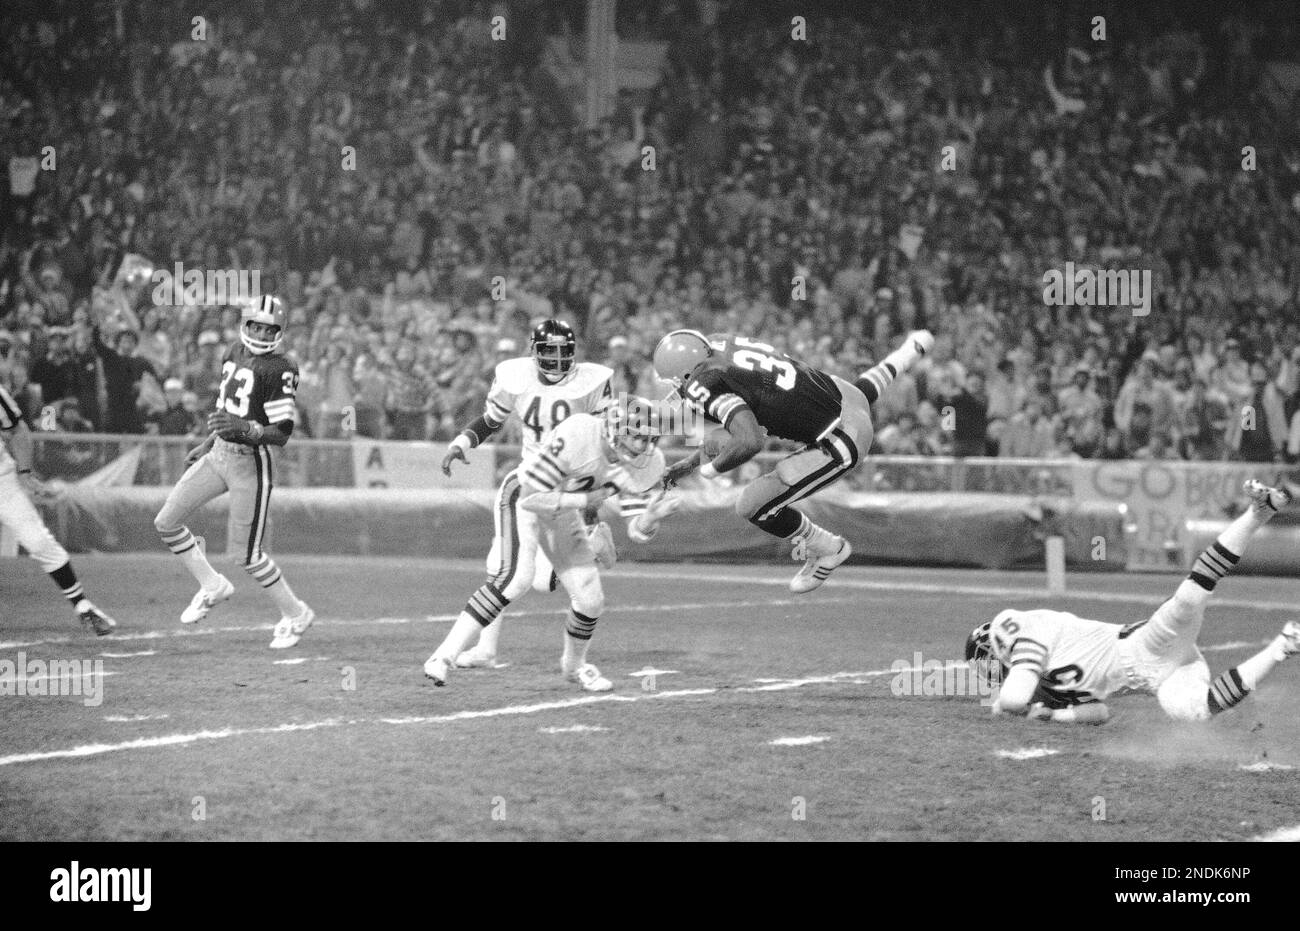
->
442, 320, 647, 668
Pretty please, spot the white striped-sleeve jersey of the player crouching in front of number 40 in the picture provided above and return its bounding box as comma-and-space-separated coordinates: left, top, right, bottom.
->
519, 413, 667, 497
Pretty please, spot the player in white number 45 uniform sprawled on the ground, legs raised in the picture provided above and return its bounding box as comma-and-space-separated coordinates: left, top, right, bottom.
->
966, 480, 1300, 724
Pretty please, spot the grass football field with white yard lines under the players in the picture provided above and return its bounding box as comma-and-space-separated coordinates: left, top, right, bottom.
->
0, 555, 1300, 841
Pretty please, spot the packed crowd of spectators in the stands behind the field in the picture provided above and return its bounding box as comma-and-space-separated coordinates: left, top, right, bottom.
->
0, 0, 1300, 462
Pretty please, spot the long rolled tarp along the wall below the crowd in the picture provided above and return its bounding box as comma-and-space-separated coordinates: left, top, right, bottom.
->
27, 486, 1127, 570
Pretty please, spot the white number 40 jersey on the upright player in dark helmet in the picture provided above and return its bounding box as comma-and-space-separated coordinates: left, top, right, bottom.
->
485, 356, 614, 455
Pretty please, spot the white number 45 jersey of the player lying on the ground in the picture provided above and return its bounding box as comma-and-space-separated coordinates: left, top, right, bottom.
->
989, 609, 1126, 702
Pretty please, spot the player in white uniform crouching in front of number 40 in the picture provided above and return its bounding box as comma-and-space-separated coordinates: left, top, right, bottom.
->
424, 402, 676, 692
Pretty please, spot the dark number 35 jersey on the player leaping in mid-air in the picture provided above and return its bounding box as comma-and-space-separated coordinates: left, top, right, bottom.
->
683, 337, 841, 443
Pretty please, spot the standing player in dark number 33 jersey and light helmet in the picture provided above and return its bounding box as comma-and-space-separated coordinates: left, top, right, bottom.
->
153, 295, 316, 650
